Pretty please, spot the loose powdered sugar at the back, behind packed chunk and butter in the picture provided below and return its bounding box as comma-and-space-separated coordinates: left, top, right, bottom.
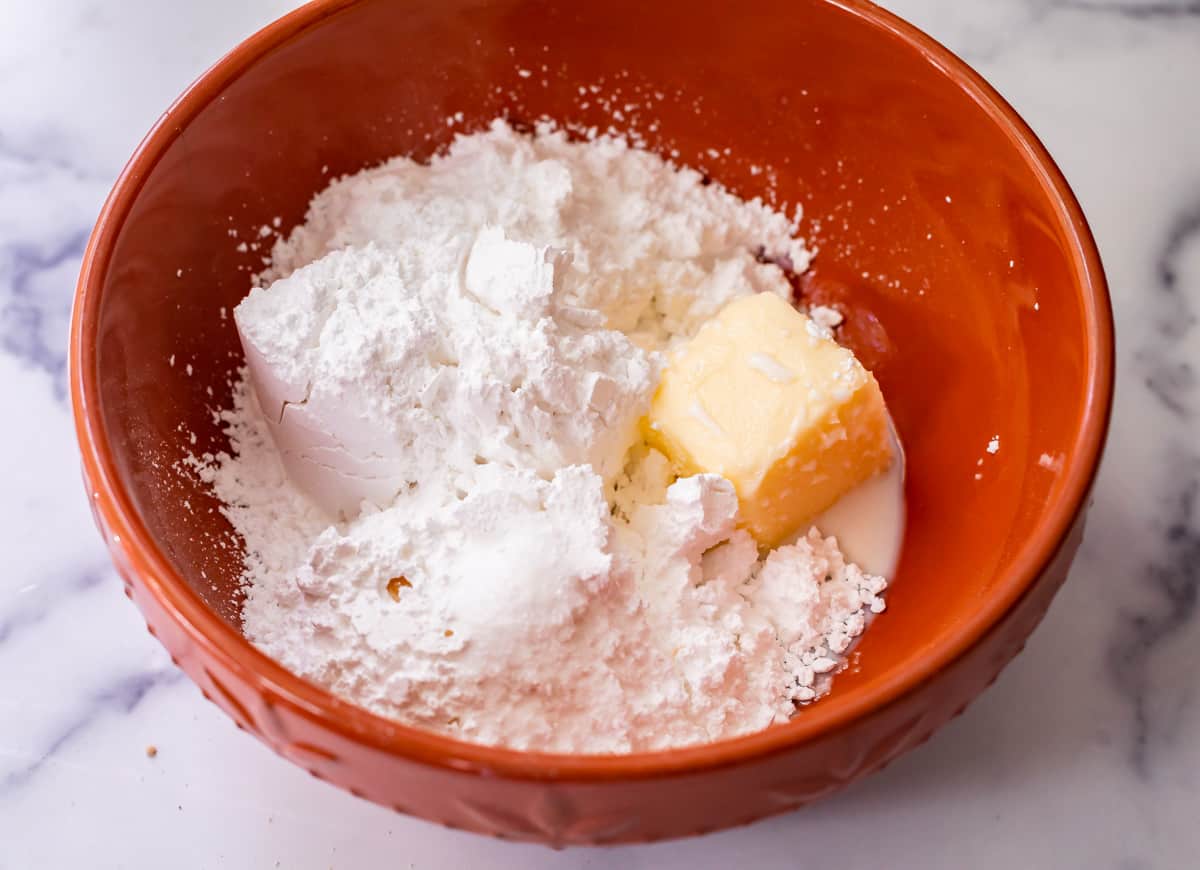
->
260, 120, 809, 347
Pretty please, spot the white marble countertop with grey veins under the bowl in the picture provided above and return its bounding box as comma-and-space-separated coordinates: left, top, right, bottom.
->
0, 0, 1200, 870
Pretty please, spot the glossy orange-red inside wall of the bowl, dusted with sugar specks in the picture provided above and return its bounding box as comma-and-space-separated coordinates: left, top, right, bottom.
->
83, 0, 1096, 727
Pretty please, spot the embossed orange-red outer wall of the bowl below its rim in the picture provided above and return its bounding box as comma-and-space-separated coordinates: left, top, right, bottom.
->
89, 472, 1084, 847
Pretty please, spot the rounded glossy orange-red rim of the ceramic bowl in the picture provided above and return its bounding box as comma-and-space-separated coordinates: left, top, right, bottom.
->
68, 0, 1115, 782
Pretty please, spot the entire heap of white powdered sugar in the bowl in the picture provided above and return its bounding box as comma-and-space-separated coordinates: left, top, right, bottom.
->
199, 124, 884, 752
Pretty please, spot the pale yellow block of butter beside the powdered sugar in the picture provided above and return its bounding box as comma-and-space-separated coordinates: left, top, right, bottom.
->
646, 293, 893, 547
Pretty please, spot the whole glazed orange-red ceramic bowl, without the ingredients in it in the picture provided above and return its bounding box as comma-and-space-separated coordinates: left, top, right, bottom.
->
71, 0, 1112, 845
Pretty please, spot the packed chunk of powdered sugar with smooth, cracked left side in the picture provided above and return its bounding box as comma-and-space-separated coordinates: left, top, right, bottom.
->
235, 227, 659, 517
